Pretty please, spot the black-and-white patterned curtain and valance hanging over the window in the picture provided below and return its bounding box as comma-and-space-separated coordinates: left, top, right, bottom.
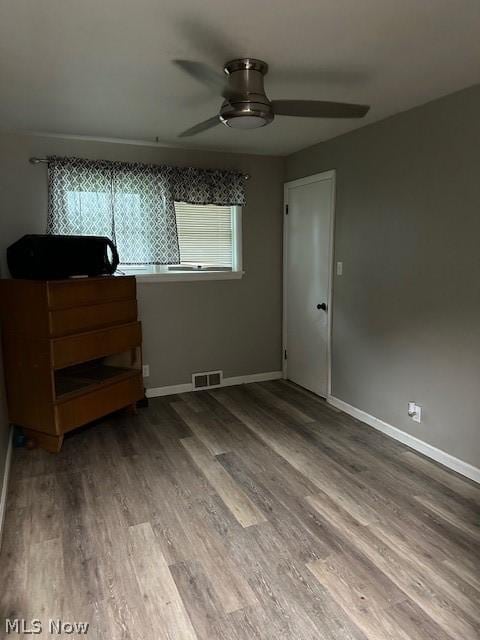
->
47, 157, 245, 264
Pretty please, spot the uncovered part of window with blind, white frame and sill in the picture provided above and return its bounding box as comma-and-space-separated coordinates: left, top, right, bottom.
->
120, 202, 242, 280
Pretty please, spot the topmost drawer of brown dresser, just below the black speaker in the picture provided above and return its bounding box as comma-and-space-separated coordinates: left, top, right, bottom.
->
47, 276, 136, 309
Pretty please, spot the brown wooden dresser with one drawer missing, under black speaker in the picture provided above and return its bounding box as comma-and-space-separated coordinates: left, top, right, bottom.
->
0, 276, 143, 451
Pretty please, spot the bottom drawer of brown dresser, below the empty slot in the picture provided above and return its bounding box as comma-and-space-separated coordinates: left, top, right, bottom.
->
55, 372, 143, 433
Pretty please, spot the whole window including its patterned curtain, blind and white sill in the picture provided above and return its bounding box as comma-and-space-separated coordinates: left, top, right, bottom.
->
47, 157, 245, 282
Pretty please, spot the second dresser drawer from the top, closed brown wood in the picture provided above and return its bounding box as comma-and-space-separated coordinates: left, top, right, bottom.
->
49, 299, 137, 336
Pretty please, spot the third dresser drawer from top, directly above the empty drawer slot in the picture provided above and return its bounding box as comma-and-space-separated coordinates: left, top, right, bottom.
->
51, 322, 142, 369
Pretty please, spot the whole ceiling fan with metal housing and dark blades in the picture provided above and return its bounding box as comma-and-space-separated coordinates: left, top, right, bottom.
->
174, 58, 370, 138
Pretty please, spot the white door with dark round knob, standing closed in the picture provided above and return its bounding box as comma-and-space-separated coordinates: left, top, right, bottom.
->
284, 171, 335, 397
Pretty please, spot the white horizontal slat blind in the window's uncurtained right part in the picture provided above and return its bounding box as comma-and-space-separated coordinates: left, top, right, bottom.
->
175, 202, 232, 267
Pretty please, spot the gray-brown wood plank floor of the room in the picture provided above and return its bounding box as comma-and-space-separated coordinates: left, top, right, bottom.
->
0, 381, 480, 640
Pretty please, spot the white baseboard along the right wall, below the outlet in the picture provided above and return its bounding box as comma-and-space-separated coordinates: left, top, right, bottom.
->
327, 396, 480, 483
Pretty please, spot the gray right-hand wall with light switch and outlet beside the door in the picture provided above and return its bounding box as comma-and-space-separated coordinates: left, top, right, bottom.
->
287, 86, 480, 466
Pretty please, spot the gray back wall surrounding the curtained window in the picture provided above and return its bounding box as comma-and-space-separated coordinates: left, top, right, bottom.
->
0, 134, 284, 404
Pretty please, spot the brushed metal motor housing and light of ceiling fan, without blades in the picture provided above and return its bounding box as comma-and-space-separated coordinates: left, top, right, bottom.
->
220, 58, 274, 129
